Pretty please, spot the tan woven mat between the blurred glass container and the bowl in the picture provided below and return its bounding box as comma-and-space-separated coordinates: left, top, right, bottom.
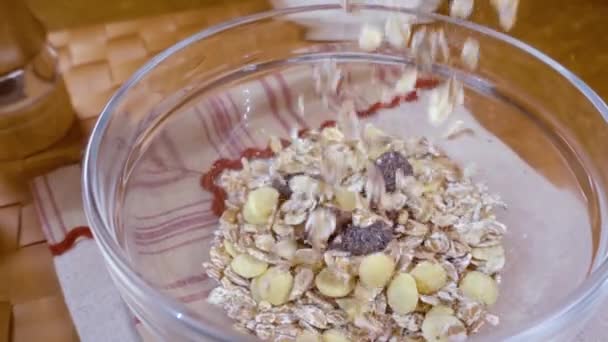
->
49, 0, 268, 127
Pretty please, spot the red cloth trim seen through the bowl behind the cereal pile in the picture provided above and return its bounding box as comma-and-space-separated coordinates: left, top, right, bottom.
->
201, 78, 439, 217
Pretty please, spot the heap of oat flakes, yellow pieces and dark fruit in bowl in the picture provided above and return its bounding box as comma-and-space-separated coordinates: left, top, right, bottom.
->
204, 118, 506, 342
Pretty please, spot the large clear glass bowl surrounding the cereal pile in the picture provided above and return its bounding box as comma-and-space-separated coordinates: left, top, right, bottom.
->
83, 5, 608, 341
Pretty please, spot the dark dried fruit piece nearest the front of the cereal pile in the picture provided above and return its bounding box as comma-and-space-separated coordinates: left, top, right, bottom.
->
339, 221, 393, 255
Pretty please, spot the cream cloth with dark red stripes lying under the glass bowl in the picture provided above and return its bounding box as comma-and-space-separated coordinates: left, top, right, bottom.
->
32, 65, 608, 341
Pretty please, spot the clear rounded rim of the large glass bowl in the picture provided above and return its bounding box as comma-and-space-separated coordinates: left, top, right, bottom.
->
82, 4, 608, 341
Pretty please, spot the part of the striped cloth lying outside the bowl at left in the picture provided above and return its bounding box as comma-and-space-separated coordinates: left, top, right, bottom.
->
31, 165, 140, 342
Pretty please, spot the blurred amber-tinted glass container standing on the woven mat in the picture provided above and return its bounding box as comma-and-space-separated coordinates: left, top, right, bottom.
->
0, 0, 74, 162
